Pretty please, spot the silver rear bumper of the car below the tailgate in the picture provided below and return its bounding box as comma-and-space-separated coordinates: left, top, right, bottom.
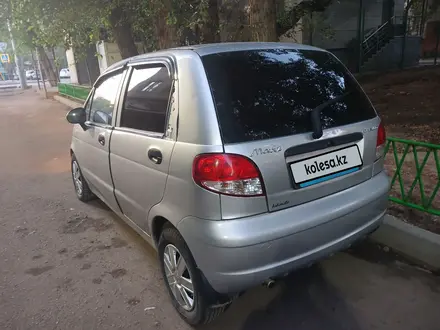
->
178, 172, 389, 293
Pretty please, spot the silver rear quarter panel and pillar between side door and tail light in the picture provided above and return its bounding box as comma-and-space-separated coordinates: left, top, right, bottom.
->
148, 51, 223, 232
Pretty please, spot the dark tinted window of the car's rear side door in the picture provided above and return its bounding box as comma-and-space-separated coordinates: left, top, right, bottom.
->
121, 66, 172, 133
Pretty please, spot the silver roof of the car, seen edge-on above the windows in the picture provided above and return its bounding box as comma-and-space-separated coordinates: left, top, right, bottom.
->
103, 42, 325, 74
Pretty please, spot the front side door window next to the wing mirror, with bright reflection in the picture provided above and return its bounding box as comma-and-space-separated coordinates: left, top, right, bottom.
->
89, 72, 122, 125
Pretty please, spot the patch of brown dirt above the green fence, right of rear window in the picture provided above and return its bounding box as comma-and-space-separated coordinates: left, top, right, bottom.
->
360, 66, 440, 145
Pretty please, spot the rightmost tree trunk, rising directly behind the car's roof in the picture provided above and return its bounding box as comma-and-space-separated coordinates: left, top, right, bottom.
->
249, 0, 278, 41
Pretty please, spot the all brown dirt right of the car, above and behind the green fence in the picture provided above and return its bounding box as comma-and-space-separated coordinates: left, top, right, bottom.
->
361, 66, 440, 234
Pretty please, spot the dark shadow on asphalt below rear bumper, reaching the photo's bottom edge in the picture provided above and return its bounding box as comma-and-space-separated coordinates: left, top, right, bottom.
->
201, 264, 360, 330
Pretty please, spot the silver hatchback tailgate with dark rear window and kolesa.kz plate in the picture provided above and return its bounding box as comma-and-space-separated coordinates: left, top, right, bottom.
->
202, 49, 380, 211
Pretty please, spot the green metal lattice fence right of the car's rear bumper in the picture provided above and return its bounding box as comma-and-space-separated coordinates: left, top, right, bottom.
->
385, 137, 440, 215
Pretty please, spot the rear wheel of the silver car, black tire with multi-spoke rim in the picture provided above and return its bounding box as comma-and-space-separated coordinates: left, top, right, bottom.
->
158, 227, 230, 326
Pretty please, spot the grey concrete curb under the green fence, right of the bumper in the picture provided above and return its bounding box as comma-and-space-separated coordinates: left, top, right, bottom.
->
371, 215, 440, 272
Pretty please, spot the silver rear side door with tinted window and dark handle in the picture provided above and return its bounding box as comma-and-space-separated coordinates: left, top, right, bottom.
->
110, 60, 175, 232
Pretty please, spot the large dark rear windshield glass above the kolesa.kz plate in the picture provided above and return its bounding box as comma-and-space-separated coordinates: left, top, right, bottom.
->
202, 49, 376, 143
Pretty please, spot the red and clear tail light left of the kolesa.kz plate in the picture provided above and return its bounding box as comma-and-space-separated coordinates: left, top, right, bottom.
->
193, 154, 264, 197
